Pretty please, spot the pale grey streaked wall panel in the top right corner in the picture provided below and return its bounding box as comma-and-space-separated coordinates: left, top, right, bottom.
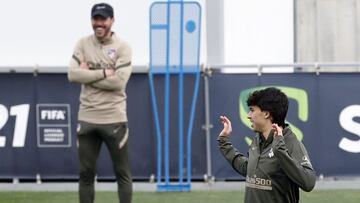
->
296, 0, 360, 63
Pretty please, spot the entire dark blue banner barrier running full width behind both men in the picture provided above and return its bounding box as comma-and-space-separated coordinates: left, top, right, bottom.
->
0, 73, 360, 179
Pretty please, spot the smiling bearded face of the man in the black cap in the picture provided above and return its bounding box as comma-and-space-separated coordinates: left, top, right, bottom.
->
91, 15, 114, 40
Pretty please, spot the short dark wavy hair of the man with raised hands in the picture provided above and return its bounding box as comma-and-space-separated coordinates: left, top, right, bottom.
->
246, 87, 289, 128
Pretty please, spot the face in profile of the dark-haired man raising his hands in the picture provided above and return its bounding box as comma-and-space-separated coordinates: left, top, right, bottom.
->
247, 106, 269, 133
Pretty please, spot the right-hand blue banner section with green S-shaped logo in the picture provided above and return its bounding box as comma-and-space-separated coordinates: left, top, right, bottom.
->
210, 73, 360, 179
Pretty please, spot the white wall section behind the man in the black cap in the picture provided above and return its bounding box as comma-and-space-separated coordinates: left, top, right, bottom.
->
0, 0, 203, 67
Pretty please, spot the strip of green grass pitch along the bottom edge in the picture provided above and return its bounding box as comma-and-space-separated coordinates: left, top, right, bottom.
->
0, 190, 360, 203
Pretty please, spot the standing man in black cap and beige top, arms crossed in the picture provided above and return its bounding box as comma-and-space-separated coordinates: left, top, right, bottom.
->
68, 3, 132, 203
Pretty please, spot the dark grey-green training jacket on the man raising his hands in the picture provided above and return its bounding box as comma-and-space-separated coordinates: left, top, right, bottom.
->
218, 127, 316, 203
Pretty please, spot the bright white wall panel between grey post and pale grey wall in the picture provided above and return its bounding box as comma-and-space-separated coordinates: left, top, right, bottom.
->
224, 0, 294, 64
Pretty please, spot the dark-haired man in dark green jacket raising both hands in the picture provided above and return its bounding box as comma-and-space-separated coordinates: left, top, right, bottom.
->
218, 88, 316, 203
